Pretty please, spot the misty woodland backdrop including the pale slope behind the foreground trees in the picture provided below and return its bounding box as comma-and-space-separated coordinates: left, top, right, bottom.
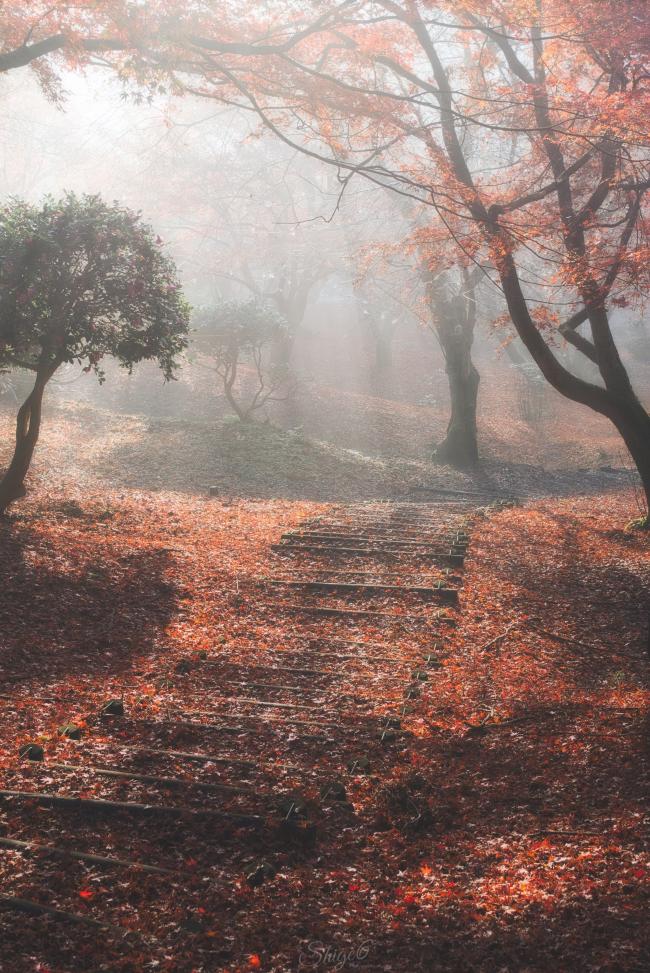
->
0, 69, 650, 499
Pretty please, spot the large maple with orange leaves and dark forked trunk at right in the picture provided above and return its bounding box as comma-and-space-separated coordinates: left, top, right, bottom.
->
5, 0, 650, 516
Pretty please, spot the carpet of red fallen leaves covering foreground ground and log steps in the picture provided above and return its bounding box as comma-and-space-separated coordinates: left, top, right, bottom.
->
0, 489, 650, 973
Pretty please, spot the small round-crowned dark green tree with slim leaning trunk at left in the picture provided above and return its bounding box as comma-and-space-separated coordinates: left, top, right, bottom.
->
0, 193, 189, 514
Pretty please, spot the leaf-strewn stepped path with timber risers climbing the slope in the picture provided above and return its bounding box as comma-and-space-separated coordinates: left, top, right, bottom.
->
0, 497, 492, 969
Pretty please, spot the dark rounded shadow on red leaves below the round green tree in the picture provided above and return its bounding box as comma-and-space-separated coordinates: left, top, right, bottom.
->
0, 522, 178, 688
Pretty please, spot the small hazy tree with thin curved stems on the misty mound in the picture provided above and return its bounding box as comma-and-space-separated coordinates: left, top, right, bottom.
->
192, 300, 289, 422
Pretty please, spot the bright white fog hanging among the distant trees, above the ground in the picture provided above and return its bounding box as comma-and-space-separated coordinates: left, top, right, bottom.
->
0, 62, 650, 494
